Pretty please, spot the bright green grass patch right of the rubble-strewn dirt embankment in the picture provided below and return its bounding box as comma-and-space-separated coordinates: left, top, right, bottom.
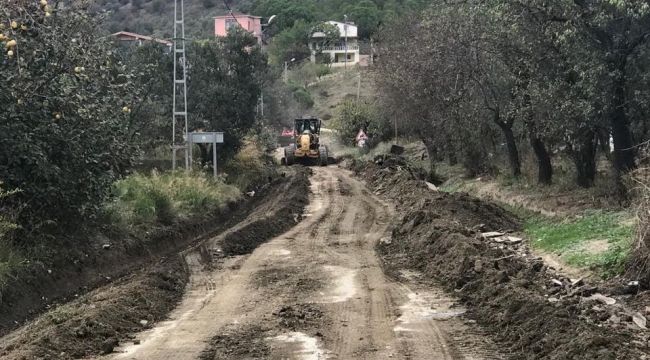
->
524, 211, 634, 278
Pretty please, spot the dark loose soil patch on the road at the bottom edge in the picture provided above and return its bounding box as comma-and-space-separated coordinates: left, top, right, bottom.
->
199, 325, 271, 360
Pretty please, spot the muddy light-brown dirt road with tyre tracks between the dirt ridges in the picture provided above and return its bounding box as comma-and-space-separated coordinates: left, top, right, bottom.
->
105, 167, 500, 360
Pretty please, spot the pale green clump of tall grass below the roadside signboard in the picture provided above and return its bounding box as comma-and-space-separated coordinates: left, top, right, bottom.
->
106, 171, 240, 226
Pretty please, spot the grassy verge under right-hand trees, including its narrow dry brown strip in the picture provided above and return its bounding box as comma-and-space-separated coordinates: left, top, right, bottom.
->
440, 170, 635, 278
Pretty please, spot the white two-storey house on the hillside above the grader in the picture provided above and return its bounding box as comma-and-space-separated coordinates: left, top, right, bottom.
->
309, 21, 359, 67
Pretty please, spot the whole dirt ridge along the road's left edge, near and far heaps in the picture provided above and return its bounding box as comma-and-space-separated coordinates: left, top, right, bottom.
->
0, 170, 309, 359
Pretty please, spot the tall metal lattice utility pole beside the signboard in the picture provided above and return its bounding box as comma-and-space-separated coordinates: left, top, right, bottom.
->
172, 0, 192, 170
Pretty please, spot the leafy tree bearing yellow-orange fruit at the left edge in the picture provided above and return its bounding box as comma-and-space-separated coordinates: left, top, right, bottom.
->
0, 0, 154, 238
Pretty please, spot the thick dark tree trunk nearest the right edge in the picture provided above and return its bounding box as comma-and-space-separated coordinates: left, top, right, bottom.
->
609, 59, 635, 174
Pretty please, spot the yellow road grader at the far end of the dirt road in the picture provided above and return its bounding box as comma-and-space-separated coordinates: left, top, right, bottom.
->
284, 117, 329, 166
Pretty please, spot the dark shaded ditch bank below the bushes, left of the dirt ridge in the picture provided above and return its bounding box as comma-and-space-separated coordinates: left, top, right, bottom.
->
0, 167, 302, 335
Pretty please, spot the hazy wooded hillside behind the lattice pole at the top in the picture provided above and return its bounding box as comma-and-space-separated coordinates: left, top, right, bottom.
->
86, 0, 250, 38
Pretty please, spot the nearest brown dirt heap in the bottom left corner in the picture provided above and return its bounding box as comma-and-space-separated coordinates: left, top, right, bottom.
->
0, 257, 188, 359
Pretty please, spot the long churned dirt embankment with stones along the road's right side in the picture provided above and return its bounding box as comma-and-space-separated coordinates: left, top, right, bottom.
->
353, 158, 648, 359
